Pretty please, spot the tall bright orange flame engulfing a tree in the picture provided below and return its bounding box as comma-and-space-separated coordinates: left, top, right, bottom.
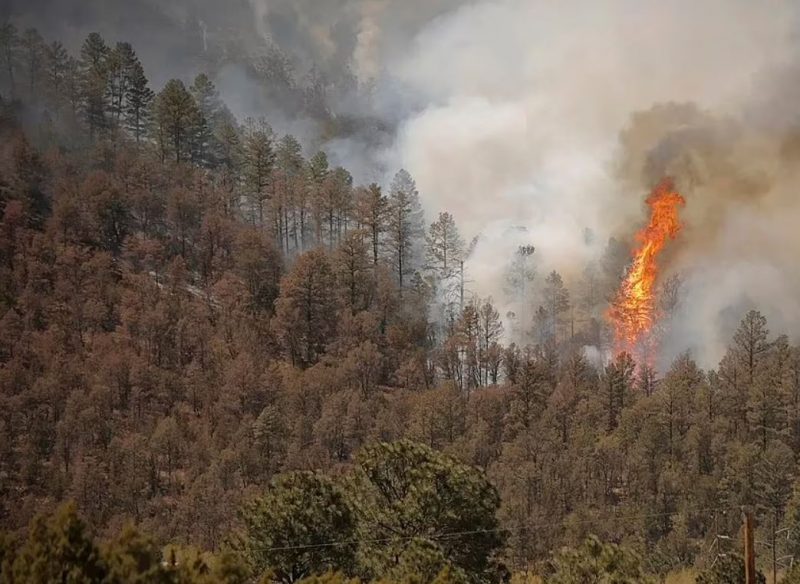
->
609, 178, 686, 364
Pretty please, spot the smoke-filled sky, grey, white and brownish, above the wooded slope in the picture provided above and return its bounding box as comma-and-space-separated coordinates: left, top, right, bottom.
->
9, 0, 800, 366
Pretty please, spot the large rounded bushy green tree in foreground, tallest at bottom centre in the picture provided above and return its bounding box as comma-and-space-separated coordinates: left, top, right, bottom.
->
353, 440, 503, 582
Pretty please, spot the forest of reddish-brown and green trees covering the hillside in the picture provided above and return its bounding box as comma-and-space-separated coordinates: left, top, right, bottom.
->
0, 23, 800, 584
